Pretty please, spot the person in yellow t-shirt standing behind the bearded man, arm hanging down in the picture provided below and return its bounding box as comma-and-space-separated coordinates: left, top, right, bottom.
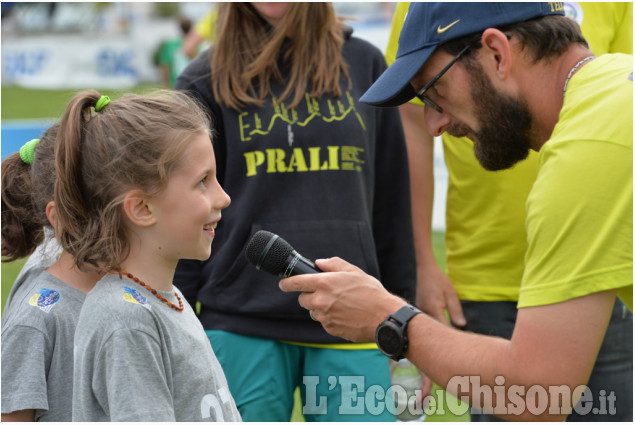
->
386, 2, 633, 421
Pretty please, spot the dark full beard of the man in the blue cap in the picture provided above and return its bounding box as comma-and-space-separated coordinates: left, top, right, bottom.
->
447, 65, 532, 171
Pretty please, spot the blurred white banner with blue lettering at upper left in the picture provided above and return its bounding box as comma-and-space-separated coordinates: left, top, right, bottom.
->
2, 35, 157, 89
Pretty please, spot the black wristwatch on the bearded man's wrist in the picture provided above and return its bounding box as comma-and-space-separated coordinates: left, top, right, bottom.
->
375, 305, 421, 360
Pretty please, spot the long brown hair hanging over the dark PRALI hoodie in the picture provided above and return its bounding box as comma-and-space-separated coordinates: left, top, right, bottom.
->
211, 2, 351, 109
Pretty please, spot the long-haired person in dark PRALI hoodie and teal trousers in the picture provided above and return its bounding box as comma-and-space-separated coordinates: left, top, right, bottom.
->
175, 3, 415, 421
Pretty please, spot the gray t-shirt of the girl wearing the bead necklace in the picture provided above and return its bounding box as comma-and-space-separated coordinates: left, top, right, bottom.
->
73, 275, 241, 422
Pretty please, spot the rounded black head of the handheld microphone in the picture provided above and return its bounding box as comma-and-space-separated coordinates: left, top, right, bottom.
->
245, 230, 293, 276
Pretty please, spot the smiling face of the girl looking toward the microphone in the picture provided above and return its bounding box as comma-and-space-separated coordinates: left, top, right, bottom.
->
150, 131, 231, 261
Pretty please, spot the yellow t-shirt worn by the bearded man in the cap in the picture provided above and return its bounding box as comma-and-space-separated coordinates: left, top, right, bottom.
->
518, 54, 633, 310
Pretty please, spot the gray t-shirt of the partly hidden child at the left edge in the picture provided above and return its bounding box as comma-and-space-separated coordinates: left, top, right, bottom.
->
2, 264, 86, 422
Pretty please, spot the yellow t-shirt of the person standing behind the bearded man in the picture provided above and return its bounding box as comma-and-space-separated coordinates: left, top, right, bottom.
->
386, 3, 633, 301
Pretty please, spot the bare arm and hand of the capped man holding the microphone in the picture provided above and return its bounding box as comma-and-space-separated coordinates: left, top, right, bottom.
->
280, 258, 616, 421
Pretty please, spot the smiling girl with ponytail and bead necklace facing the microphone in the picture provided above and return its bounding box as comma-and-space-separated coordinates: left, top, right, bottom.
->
55, 90, 240, 422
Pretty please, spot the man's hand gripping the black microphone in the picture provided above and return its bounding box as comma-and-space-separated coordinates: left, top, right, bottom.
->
280, 257, 407, 342
